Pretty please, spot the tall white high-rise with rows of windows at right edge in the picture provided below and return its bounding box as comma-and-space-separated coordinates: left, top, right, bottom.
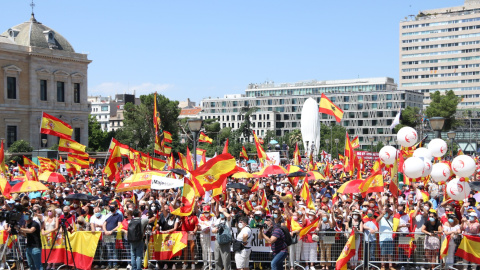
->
399, 0, 480, 109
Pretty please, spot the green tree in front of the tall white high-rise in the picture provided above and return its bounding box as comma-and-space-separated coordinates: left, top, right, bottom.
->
425, 90, 461, 131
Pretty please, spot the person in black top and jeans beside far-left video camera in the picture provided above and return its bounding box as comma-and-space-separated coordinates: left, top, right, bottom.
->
19, 212, 43, 270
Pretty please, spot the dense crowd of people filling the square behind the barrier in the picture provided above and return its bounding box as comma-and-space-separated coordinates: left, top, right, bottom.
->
0, 157, 480, 270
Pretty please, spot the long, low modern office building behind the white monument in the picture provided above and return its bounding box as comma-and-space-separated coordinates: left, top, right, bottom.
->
200, 77, 422, 150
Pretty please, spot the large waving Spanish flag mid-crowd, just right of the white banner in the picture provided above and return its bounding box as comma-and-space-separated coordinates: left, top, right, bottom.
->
191, 154, 237, 196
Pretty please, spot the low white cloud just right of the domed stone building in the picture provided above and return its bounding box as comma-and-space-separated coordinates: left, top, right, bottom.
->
88, 82, 173, 97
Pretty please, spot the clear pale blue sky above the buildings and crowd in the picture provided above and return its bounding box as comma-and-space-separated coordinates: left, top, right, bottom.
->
0, 0, 463, 102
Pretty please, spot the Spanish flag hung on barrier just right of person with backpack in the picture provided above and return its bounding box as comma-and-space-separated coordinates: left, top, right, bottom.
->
152, 232, 187, 260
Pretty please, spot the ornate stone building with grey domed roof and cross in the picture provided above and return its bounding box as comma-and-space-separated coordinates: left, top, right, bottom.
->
0, 13, 91, 149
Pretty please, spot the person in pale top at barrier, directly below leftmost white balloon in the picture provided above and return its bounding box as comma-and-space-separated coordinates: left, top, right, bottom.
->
378, 206, 394, 270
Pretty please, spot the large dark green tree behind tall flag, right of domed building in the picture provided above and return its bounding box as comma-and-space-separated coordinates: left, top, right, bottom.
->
115, 93, 185, 153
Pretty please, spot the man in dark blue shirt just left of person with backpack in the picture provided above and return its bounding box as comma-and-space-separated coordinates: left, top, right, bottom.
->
103, 203, 123, 269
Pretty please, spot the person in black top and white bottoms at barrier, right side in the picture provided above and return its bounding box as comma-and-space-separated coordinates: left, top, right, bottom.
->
422, 212, 443, 269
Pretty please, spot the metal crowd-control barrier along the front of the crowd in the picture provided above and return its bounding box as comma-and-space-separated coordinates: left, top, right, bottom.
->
6, 231, 477, 269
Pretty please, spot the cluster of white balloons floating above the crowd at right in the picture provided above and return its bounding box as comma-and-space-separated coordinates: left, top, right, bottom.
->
379, 127, 475, 200
